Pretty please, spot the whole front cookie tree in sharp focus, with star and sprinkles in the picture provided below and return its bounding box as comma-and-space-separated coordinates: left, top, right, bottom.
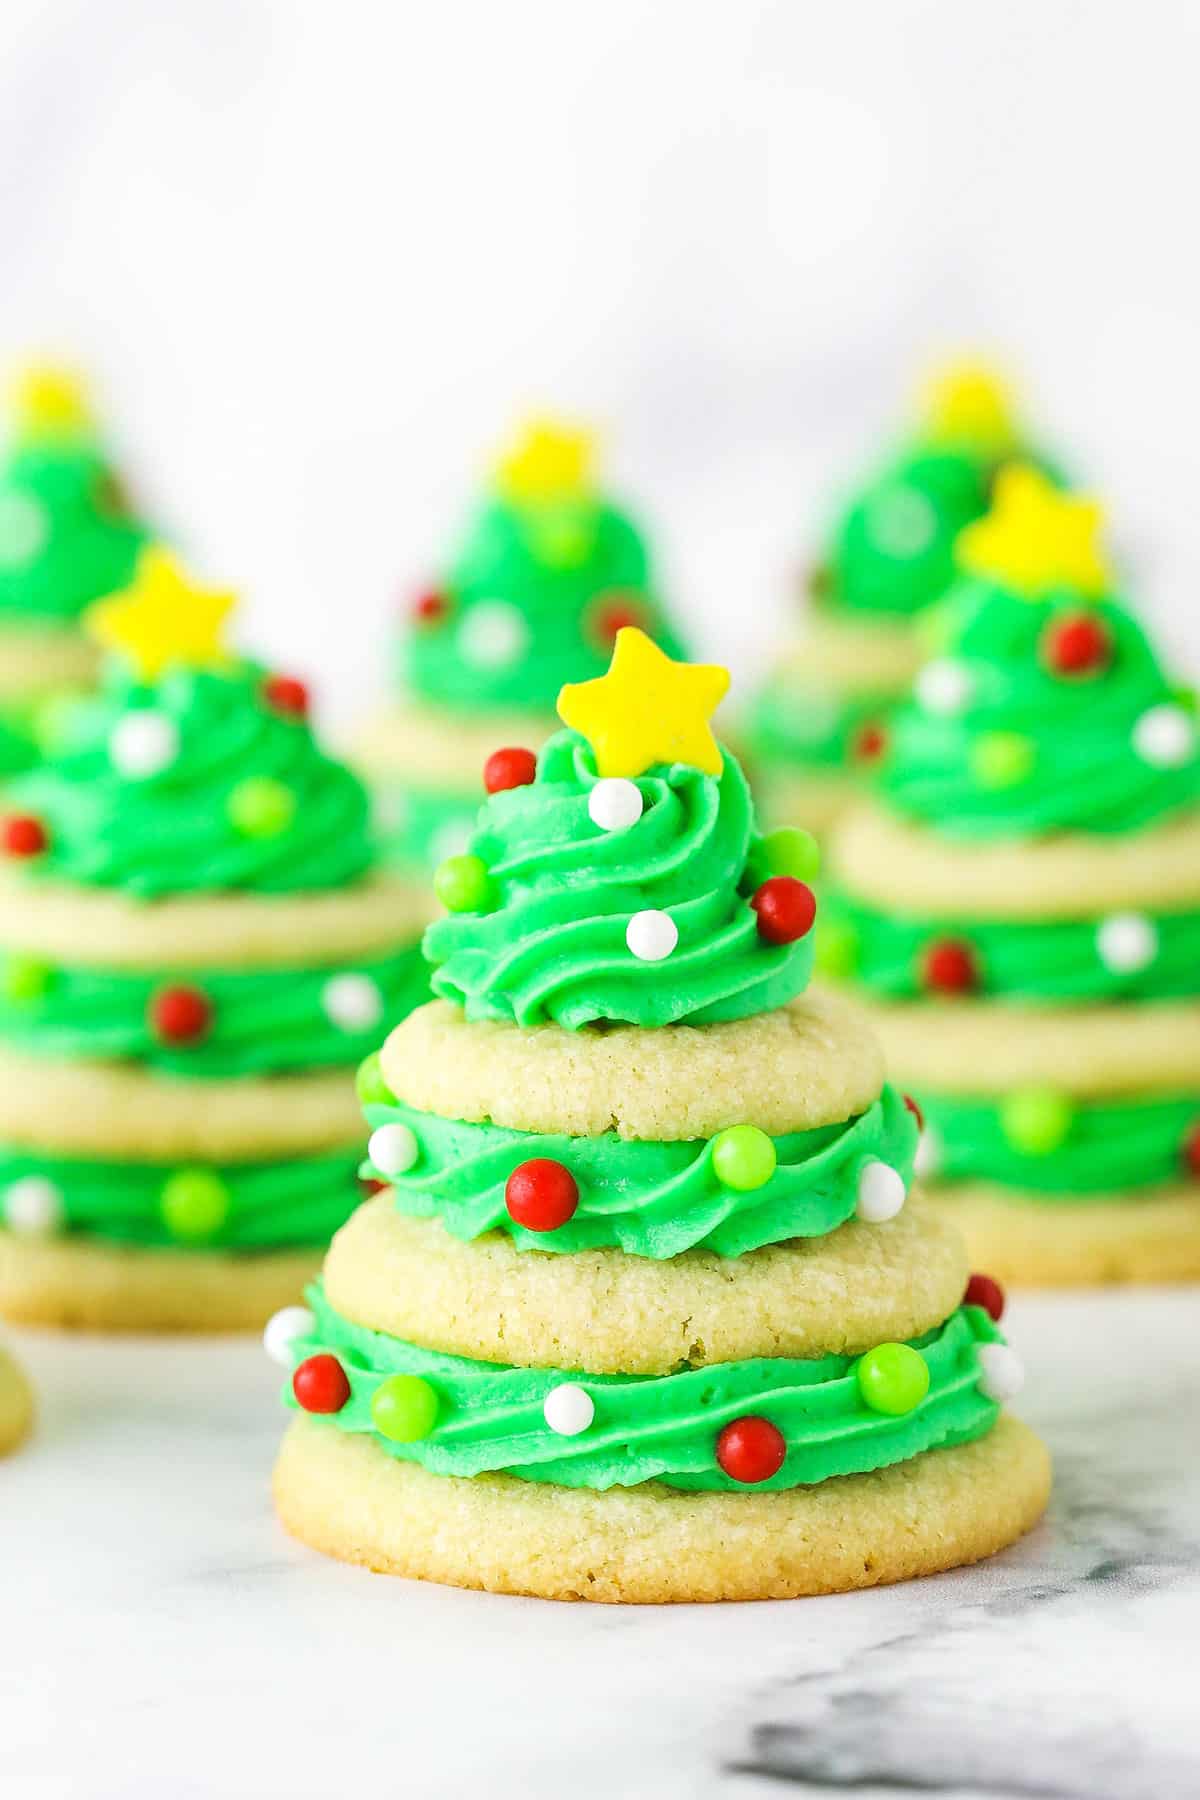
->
268, 630, 1047, 1602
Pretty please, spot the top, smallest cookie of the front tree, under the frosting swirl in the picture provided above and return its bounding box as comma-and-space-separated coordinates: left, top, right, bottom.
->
380, 990, 883, 1141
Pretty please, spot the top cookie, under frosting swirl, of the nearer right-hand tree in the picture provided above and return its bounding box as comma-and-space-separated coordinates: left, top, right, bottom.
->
828, 805, 1200, 922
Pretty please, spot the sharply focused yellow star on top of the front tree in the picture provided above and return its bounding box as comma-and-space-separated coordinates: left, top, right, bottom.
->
558, 625, 729, 776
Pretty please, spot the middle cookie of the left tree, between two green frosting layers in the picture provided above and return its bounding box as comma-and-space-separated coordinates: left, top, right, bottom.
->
0, 1048, 363, 1163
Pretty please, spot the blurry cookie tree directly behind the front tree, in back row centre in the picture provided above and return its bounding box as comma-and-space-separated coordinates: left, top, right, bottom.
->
358, 421, 690, 869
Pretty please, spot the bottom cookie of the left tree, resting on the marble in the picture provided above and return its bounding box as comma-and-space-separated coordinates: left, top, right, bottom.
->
0, 1231, 324, 1332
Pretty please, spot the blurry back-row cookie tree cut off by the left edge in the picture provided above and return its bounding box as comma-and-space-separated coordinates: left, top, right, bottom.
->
0, 367, 144, 774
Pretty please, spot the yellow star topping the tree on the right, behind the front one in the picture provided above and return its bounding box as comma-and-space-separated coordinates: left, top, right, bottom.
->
955, 463, 1112, 599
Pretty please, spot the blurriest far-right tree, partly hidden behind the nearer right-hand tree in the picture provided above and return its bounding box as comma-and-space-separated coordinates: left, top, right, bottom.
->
748, 365, 1050, 833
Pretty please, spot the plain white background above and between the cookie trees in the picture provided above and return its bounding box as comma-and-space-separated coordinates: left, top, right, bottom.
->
0, 0, 1200, 722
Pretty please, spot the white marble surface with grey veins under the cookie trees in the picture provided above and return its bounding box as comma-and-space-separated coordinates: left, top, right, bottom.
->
0, 1291, 1200, 1800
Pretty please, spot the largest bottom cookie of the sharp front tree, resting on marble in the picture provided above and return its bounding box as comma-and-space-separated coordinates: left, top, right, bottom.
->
275, 1415, 1051, 1606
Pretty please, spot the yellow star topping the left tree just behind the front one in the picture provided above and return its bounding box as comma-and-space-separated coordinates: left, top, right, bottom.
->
85, 544, 234, 680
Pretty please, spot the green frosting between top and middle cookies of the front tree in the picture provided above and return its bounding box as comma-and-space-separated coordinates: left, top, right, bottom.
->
362, 1087, 918, 1260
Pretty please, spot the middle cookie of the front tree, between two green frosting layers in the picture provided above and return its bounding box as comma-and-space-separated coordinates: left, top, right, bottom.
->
326, 1192, 968, 1375
